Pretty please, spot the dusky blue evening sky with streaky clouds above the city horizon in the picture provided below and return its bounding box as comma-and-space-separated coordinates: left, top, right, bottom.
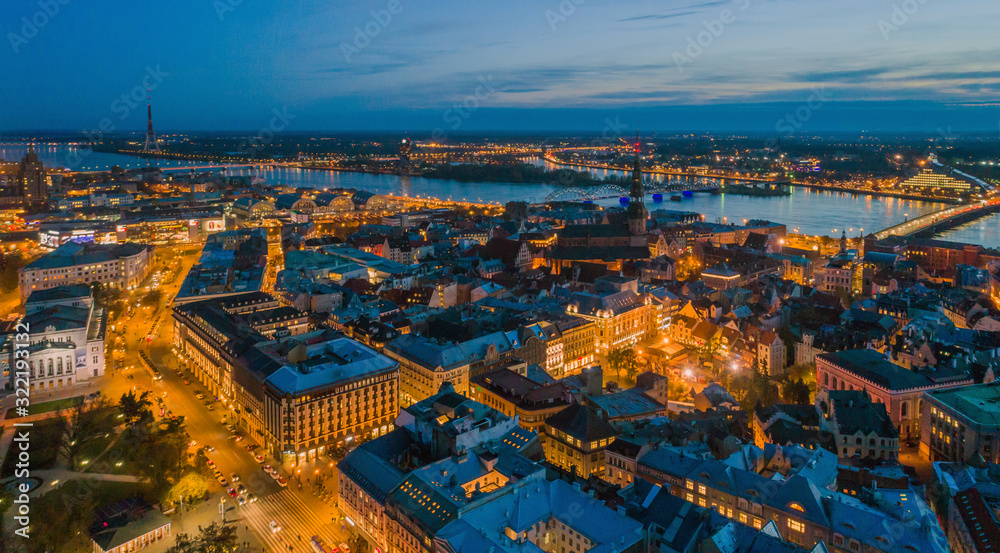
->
0, 0, 1000, 132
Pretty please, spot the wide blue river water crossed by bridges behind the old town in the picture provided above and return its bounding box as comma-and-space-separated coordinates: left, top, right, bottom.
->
0, 144, 1000, 247
